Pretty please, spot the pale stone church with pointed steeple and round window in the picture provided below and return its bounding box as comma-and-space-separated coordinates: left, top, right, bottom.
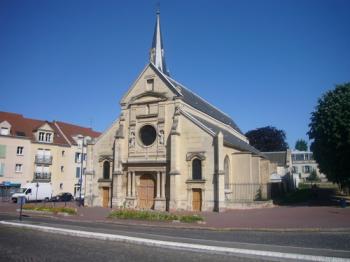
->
85, 12, 274, 211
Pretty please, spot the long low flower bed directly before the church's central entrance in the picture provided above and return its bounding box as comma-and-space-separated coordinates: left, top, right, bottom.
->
108, 209, 203, 223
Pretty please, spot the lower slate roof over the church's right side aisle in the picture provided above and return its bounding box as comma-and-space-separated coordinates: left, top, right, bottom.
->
187, 112, 265, 157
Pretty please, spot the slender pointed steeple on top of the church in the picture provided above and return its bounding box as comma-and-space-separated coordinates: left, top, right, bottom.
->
150, 9, 169, 75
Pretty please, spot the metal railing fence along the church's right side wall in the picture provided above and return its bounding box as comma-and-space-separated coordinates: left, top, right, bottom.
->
225, 183, 271, 203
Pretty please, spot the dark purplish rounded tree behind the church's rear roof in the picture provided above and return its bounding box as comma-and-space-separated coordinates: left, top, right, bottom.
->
245, 126, 288, 152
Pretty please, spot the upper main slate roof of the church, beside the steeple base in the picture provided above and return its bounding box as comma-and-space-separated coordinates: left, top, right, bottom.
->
166, 76, 243, 134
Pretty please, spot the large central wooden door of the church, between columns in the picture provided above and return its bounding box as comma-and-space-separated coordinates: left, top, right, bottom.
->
138, 175, 155, 209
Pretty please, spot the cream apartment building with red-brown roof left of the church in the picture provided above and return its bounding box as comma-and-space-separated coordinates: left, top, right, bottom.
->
0, 112, 100, 198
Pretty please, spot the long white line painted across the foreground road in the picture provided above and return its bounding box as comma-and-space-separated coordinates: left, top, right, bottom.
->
0, 221, 350, 262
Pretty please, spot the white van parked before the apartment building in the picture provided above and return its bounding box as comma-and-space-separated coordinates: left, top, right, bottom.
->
11, 183, 52, 203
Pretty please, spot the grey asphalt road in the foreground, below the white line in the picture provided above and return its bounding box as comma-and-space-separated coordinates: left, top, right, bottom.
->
0, 226, 264, 262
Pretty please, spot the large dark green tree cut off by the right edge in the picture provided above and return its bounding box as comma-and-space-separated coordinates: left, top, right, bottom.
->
308, 83, 350, 187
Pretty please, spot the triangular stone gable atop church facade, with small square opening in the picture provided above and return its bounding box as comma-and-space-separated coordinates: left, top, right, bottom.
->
120, 63, 181, 106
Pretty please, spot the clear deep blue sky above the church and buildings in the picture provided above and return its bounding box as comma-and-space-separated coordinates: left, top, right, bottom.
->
0, 0, 350, 147
